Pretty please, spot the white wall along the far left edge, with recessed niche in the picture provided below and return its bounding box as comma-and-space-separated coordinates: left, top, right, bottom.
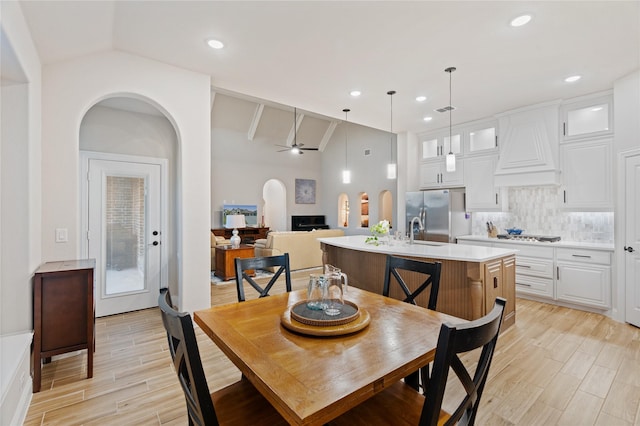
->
0, 2, 41, 424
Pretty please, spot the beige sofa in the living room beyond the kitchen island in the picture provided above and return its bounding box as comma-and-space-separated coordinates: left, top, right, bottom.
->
254, 229, 344, 271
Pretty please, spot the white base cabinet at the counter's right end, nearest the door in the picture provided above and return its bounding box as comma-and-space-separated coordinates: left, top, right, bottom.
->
556, 249, 611, 309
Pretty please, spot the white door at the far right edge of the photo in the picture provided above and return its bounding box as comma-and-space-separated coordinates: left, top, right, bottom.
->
623, 155, 640, 327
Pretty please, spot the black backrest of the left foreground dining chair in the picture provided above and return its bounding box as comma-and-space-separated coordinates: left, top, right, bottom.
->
158, 288, 218, 426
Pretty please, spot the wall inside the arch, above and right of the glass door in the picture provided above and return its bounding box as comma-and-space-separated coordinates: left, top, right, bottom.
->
80, 105, 179, 295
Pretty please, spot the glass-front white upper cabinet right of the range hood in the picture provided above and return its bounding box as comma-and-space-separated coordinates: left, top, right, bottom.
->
562, 92, 613, 141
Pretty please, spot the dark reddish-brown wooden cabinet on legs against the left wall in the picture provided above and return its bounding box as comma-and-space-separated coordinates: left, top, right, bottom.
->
33, 259, 96, 393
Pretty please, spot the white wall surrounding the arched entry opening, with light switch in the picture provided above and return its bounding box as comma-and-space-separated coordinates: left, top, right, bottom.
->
42, 52, 211, 311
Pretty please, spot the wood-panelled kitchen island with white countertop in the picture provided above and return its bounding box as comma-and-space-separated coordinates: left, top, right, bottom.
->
318, 235, 517, 328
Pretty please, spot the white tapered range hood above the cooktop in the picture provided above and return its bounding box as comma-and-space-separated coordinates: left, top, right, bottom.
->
494, 102, 560, 186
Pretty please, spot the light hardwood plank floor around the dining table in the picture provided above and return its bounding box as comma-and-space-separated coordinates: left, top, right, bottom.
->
25, 271, 640, 426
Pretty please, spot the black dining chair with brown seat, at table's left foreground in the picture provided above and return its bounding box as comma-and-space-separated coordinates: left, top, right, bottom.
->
158, 288, 287, 426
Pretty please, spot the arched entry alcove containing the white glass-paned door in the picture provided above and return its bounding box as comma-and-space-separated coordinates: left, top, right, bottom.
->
79, 96, 177, 316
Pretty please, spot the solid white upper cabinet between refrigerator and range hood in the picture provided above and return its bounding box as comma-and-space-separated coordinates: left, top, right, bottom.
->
464, 155, 508, 211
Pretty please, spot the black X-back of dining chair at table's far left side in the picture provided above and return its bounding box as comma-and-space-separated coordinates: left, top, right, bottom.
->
235, 253, 291, 302
